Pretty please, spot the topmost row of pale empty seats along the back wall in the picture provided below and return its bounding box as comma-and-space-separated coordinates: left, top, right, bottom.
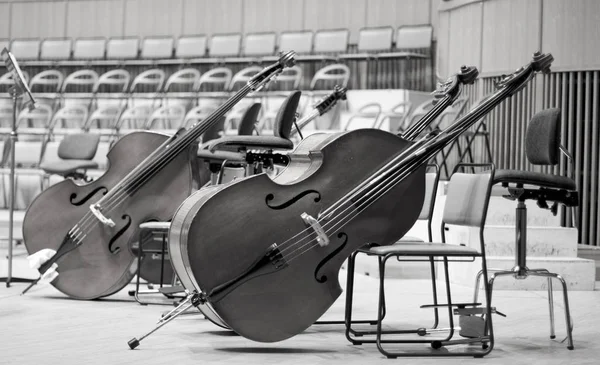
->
0, 25, 432, 64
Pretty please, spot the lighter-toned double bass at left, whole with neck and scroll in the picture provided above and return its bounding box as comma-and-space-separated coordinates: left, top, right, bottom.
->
23, 52, 294, 299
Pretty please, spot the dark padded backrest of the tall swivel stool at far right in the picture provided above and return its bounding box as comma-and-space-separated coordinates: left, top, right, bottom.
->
525, 108, 561, 165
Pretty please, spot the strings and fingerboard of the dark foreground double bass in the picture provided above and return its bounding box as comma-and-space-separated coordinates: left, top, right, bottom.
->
278, 78, 517, 263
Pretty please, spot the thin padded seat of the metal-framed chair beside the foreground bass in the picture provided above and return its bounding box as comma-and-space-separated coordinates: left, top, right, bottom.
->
367, 242, 481, 257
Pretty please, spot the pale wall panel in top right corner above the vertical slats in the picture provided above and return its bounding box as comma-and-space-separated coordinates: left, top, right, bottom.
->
542, 0, 600, 70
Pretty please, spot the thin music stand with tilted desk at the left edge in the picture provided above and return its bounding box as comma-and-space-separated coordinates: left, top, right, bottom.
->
0, 48, 35, 287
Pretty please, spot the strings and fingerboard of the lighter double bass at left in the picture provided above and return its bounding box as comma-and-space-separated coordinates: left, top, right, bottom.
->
75, 85, 250, 240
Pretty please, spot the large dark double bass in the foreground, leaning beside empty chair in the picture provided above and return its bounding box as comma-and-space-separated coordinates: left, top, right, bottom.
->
169, 54, 552, 342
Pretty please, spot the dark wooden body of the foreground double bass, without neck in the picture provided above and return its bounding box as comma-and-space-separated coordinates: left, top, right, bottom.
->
169, 129, 425, 342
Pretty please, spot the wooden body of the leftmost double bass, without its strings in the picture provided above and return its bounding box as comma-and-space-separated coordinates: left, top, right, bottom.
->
23, 132, 197, 299
